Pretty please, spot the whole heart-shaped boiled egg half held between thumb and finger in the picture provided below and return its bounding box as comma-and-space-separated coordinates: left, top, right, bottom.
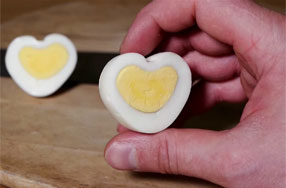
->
99, 52, 192, 133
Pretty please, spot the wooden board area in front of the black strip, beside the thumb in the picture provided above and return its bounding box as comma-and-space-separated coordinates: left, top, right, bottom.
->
0, 78, 221, 188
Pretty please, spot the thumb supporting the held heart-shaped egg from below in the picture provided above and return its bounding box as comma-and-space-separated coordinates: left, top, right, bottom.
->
105, 129, 230, 183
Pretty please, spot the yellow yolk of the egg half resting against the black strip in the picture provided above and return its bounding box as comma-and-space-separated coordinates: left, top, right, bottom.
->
19, 43, 68, 79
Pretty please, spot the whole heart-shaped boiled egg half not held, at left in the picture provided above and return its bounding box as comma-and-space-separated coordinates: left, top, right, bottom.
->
6, 34, 77, 97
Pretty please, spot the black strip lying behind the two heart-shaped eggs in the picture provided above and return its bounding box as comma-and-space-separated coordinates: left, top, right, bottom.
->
0, 49, 118, 84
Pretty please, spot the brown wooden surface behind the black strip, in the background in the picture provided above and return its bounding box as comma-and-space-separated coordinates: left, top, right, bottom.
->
0, 0, 285, 52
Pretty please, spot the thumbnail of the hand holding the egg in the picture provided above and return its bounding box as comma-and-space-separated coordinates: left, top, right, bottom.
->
105, 142, 137, 170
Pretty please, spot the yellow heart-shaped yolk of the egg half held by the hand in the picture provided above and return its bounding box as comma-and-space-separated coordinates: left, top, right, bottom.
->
116, 65, 178, 113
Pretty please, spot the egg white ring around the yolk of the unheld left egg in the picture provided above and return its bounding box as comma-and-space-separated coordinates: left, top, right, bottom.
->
5, 34, 77, 97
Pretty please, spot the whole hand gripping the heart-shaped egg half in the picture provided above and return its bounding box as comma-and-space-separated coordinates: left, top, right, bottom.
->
105, 0, 286, 187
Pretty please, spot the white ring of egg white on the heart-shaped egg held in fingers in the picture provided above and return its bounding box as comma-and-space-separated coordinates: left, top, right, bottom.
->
99, 52, 192, 133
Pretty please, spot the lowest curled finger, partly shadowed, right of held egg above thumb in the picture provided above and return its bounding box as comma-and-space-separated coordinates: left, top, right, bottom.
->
188, 77, 247, 115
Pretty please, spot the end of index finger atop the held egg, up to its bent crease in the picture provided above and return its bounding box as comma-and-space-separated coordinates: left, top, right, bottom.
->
120, 0, 194, 55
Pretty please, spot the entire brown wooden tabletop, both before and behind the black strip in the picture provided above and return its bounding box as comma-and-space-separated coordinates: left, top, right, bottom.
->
0, 0, 285, 188
